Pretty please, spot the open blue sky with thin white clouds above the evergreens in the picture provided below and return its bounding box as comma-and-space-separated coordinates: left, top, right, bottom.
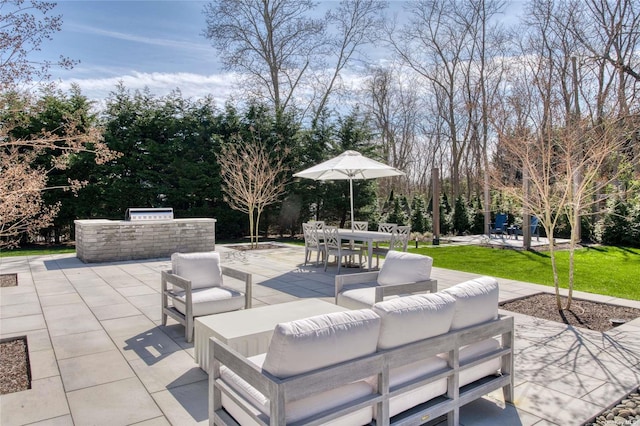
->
36, 0, 520, 104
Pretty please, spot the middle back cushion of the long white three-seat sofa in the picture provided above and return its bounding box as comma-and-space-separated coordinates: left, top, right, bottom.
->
373, 293, 456, 349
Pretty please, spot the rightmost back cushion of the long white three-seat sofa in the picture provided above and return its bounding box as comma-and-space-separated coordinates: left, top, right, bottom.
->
441, 277, 499, 330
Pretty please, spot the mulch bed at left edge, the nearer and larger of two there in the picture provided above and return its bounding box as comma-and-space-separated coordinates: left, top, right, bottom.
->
0, 337, 31, 395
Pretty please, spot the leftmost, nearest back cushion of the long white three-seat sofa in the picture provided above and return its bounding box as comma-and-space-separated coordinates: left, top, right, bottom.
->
262, 309, 380, 378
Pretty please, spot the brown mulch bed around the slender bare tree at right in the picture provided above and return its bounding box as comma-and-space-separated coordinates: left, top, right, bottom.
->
500, 293, 640, 332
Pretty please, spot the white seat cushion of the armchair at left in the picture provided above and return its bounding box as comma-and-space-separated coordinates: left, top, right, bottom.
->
173, 287, 245, 317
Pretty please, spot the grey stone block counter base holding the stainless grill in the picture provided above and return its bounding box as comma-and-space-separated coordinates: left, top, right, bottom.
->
75, 219, 216, 263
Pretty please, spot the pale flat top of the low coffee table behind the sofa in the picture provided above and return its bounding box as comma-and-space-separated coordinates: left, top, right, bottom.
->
195, 299, 348, 339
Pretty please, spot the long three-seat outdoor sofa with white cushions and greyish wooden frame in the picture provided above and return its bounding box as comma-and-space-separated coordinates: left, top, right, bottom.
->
209, 277, 514, 425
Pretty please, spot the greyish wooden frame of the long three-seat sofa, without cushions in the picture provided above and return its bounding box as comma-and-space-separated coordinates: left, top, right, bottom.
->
209, 315, 514, 426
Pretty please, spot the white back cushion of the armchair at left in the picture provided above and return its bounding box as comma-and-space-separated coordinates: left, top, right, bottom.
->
171, 251, 222, 288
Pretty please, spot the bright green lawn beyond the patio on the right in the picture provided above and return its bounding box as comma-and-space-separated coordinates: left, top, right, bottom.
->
409, 246, 640, 300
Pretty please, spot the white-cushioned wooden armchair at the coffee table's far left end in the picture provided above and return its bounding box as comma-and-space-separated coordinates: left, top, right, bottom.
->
161, 252, 252, 342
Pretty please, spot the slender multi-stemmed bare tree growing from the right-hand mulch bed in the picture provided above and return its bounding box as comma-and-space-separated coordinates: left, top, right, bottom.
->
494, 116, 639, 310
